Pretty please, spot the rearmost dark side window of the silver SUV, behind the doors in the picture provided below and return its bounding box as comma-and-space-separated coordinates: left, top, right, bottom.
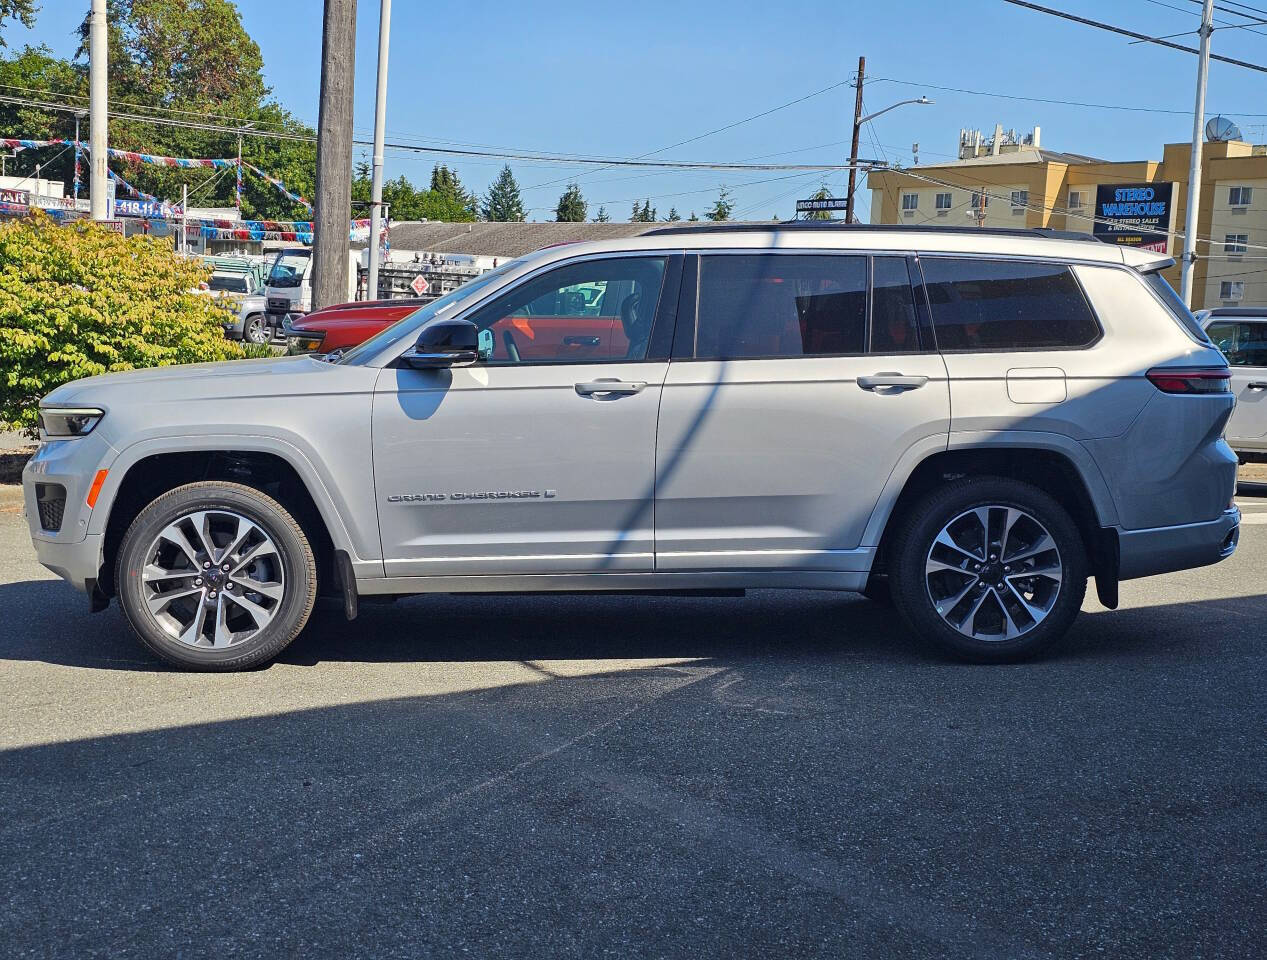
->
922, 257, 1100, 351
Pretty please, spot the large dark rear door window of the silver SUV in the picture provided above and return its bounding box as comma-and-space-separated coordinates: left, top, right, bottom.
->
696, 255, 867, 360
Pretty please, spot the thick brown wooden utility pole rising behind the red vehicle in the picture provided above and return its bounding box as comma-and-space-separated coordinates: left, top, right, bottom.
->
312, 0, 356, 310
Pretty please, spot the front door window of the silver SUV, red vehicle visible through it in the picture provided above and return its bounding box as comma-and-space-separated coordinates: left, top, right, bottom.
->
470, 257, 665, 363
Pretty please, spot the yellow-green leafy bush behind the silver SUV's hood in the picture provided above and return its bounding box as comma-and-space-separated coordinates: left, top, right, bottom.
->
0, 213, 243, 432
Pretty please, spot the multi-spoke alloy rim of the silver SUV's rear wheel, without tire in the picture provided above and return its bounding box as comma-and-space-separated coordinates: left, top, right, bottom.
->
924, 504, 1063, 641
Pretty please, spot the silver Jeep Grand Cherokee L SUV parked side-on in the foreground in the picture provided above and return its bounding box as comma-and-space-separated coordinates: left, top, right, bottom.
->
24, 224, 1239, 670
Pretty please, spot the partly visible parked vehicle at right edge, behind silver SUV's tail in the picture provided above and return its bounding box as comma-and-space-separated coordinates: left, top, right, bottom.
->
1197, 306, 1267, 458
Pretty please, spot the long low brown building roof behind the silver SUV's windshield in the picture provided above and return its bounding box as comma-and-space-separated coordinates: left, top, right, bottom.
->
375, 220, 734, 257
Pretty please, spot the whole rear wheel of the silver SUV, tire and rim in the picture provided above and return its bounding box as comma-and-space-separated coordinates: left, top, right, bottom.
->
889, 477, 1087, 662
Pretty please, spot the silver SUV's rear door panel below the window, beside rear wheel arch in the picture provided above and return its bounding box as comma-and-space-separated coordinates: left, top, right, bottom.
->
655, 353, 950, 570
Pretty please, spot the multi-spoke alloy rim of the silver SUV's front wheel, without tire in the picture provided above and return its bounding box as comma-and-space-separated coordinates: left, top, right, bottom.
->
141, 510, 286, 647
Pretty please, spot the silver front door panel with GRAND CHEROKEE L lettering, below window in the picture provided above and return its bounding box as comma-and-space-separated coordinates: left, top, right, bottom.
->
372, 362, 668, 576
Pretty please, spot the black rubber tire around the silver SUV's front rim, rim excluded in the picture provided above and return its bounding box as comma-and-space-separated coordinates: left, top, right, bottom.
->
115, 480, 317, 671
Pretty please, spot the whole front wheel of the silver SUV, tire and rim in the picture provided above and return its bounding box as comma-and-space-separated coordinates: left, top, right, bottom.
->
115, 481, 317, 670
